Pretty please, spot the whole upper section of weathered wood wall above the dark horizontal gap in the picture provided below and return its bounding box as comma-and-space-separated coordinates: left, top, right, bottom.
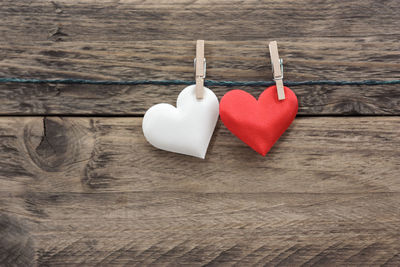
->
0, 0, 400, 115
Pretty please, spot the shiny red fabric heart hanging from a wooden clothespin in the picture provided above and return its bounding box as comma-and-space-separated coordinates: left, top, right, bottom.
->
219, 85, 298, 156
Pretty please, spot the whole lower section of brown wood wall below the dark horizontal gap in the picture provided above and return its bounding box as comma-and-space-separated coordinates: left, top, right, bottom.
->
0, 117, 400, 266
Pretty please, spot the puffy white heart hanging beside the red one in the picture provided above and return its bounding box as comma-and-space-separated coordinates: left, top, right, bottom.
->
142, 85, 218, 159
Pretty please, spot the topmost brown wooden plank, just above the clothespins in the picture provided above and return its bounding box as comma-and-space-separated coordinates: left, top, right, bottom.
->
1, 0, 400, 43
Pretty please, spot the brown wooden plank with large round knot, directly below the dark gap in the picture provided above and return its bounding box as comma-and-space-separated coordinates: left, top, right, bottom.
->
0, 117, 400, 193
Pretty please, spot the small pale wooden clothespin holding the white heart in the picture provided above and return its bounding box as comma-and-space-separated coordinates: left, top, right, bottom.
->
194, 40, 206, 99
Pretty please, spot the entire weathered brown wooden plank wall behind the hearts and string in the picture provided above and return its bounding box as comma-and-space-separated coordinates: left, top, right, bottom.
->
0, 0, 400, 266
